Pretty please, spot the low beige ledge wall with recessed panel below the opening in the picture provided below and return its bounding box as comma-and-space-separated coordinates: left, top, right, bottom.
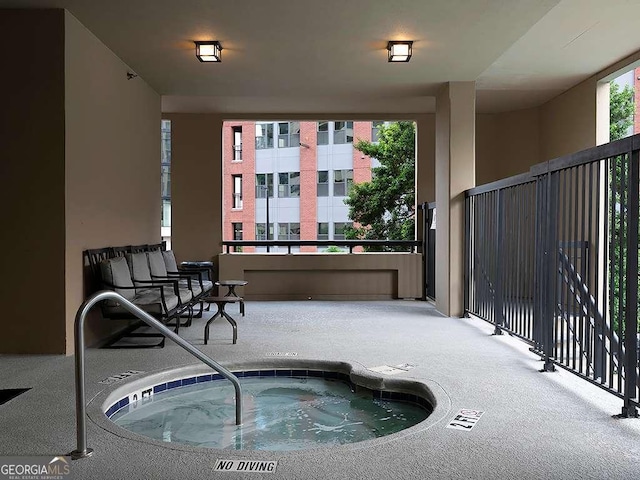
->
218, 253, 422, 300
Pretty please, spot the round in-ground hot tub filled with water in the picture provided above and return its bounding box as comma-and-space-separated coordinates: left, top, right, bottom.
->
95, 361, 436, 450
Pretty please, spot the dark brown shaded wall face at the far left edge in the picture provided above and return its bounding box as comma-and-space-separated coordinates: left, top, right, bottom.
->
0, 10, 65, 353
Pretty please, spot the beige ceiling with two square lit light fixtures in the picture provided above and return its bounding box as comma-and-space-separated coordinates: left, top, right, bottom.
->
0, 0, 640, 117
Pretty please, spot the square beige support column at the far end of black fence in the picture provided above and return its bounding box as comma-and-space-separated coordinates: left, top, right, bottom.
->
435, 82, 476, 317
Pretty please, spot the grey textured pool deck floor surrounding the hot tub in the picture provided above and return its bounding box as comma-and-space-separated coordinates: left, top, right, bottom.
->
0, 300, 640, 480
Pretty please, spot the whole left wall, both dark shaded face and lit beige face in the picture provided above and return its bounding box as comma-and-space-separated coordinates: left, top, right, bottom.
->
0, 6, 160, 354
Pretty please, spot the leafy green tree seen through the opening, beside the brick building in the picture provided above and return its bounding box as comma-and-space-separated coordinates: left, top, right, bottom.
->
344, 122, 415, 250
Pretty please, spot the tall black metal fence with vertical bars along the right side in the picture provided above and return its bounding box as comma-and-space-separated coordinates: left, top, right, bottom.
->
465, 135, 640, 416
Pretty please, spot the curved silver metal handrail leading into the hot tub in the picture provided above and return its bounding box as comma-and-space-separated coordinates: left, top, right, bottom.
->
70, 290, 242, 460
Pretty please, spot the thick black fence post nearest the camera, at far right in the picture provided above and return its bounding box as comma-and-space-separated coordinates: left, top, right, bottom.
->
621, 150, 640, 418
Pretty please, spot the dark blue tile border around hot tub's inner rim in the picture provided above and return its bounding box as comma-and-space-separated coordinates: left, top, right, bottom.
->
104, 369, 433, 418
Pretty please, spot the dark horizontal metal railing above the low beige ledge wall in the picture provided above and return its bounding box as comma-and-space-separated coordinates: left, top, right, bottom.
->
222, 240, 422, 254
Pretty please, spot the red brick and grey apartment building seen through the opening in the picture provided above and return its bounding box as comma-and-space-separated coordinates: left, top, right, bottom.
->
222, 121, 383, 252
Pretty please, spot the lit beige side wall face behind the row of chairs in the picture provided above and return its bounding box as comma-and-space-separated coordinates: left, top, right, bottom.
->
64, 12, 161, 352
